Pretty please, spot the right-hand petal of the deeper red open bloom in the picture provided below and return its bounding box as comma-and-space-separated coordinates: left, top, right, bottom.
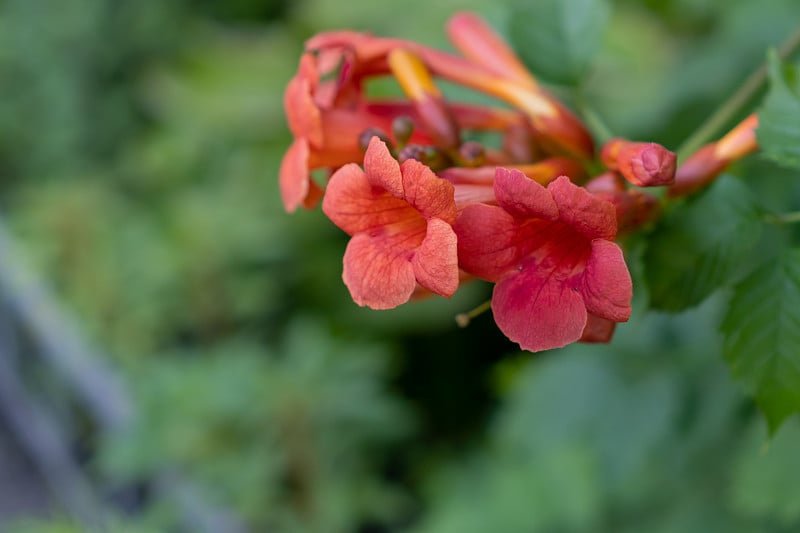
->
581, 239, 633, 322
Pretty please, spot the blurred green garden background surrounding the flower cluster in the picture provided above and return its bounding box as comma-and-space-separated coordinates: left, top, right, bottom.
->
0, 0, 800, 533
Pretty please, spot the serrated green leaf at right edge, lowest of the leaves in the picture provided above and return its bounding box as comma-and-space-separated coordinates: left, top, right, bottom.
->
722, 249, 800, 433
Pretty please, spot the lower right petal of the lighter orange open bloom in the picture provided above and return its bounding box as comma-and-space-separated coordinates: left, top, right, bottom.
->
411, 218, 458, 298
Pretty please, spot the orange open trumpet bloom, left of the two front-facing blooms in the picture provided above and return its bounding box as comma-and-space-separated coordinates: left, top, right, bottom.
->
322, 137, 459, 309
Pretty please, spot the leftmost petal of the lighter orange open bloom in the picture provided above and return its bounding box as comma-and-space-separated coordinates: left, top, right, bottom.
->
322, 163, 418, 235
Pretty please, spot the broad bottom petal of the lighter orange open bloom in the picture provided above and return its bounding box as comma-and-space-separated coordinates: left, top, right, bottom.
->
342, 233, 417, 309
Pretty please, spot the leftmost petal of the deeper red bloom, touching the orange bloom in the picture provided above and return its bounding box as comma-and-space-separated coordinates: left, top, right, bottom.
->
453, 204, 519, 281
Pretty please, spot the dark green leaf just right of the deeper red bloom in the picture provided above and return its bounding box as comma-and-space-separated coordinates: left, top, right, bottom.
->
644, 175, 761, 311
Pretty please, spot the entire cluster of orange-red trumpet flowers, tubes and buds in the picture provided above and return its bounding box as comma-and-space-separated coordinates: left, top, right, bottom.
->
280, 13, 756, 351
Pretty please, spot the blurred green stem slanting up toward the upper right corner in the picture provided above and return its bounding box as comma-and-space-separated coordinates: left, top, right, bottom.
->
677, 28, 800, 161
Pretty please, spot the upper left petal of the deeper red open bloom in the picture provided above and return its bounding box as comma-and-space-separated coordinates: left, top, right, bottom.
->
494, 167, 558, 220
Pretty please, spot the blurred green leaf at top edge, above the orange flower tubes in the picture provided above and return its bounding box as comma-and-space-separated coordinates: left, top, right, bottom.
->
508, 0, 610, 85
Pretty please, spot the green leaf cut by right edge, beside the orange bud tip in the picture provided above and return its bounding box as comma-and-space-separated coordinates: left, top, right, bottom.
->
756, 50, 800, 168
